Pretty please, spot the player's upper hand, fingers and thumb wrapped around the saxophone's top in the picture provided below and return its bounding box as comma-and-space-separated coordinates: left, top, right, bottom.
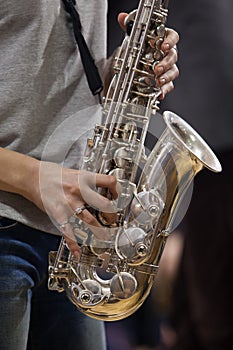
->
118, 12, 179, 100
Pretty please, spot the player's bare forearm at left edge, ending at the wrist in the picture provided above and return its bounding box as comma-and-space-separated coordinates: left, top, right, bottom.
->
0, 148, 40, 201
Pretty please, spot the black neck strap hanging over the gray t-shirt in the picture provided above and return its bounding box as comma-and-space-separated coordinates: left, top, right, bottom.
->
63, 0, 103, 95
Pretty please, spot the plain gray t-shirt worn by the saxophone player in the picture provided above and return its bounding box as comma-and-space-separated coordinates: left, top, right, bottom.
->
0, 0, 107, 233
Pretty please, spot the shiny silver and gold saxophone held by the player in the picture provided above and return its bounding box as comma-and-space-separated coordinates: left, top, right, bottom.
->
48, 0, 221, 321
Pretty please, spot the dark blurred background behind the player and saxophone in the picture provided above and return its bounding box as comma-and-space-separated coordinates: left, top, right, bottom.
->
106, 0, 233, 350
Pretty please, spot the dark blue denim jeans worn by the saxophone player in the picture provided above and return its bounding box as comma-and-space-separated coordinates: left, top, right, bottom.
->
0, 217, 106, 350
